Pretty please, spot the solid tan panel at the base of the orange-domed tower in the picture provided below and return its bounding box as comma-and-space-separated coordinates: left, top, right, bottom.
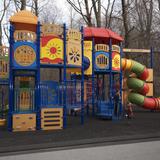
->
13, 114, 36, 132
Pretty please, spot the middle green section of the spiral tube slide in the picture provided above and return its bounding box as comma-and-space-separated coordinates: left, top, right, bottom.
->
127, 78, 144, 91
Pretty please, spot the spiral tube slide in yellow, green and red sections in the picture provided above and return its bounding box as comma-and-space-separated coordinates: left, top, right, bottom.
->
122, 58, 160, 110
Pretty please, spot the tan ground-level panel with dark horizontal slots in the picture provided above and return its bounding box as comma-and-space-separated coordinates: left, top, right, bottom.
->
41, 108, 63, 130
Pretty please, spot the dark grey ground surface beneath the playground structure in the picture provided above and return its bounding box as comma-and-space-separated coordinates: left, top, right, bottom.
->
0, 111, 160, 155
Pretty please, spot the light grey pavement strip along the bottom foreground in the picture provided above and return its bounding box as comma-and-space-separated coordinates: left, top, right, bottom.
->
0, 141, 160, 160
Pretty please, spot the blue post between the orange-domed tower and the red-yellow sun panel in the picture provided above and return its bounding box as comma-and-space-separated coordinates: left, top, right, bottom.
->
35, 22, 41, 130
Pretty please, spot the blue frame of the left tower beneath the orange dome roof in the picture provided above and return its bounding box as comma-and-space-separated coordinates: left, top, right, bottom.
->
8, 22, 41, 131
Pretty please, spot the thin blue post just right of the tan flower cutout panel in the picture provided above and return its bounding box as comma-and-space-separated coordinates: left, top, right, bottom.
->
81, 26, 84, 124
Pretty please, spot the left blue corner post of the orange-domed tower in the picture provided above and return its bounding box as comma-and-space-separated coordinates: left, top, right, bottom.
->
8, 24, 14, 131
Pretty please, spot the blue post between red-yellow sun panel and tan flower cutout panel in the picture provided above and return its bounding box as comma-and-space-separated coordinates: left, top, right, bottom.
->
63, 24, 67, 128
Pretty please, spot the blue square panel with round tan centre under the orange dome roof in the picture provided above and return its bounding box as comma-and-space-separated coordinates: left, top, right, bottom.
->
13, 42, 36, 68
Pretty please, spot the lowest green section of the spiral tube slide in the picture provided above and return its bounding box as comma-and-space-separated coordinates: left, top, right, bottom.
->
128, 93, 144, 106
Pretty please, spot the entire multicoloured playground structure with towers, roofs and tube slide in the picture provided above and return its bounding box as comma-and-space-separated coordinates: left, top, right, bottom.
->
0, 11, 160, 131
